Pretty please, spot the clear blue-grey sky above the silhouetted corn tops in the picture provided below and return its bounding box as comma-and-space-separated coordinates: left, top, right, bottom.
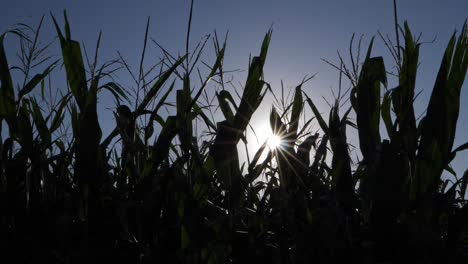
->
0, 0, 468, 177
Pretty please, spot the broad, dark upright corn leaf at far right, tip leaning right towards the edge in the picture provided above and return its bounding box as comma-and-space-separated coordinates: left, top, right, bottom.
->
411, 23, 468, 199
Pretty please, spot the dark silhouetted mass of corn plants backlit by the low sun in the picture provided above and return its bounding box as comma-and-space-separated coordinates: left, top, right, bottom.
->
0, 8, 468, 263
